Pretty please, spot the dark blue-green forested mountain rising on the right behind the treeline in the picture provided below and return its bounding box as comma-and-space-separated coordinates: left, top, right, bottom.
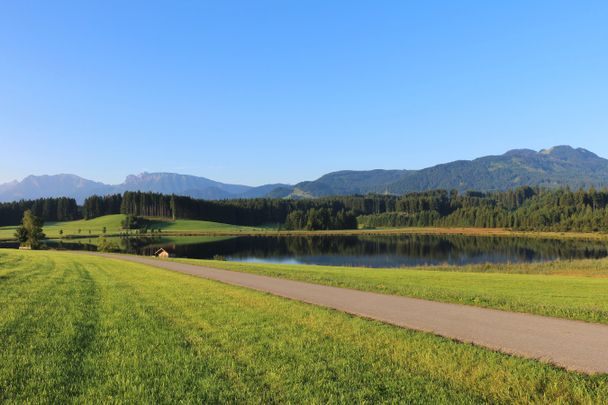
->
293, 146, 608, 197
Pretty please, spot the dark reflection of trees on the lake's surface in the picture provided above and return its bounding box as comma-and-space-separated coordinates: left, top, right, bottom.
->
154, 235, 608, 262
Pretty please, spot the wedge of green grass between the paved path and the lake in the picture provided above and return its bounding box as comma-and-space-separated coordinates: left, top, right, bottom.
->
177, 259, 608, 323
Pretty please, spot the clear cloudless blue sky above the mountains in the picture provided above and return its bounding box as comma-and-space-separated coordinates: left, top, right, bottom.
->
0, 0, 608, 185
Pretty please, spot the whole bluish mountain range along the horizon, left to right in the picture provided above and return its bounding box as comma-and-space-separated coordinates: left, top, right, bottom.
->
0, 146, 608, 203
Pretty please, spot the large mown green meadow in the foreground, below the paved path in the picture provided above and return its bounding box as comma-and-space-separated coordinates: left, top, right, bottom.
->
0, 250, 608, 403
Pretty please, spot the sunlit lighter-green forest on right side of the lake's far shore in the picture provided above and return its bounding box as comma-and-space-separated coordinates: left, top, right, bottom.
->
358, 187, 608, 232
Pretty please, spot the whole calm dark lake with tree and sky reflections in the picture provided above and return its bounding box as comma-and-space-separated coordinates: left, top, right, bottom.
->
25, 235, 608, 267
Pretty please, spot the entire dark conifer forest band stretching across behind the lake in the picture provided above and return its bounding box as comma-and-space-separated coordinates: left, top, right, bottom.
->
7, 187, 608, 232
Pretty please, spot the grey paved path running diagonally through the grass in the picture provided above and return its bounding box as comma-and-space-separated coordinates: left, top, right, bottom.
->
94, 254, 608, 373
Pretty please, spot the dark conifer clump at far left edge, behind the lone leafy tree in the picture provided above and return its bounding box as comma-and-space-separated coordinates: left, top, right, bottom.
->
0, 197, 81, 226
